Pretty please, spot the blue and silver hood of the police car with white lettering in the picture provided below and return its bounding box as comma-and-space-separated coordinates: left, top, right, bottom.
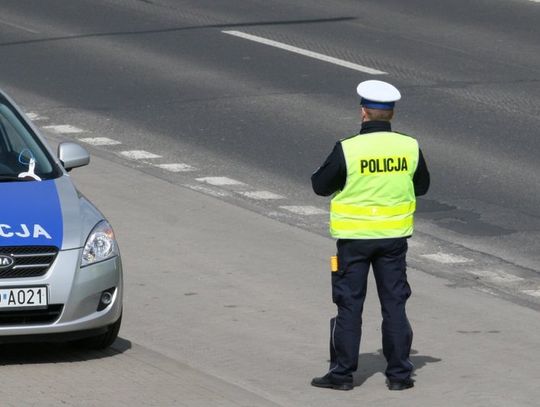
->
0, 175, 104, 250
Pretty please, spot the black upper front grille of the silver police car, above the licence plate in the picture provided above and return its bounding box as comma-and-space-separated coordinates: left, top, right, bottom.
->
0, 246, 58, 278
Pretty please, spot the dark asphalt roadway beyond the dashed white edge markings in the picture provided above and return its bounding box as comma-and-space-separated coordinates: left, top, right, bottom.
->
0, 0, 540, 272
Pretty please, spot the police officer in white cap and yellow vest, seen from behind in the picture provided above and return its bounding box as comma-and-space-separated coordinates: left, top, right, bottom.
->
311, 80, 429, 390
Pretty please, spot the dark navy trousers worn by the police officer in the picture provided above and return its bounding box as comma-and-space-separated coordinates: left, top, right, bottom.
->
330, 238, 413, 380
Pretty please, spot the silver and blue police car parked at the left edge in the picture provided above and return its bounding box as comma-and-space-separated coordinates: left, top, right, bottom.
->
0, 91, 122, 349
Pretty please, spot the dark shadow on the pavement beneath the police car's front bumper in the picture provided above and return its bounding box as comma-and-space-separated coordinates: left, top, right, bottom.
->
0, 338, 131, 366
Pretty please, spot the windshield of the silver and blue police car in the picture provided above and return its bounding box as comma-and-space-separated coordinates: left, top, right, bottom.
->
0, 97, 61, 182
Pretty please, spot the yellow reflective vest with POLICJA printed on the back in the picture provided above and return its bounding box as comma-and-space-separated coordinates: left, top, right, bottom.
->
330, 132, 419, 239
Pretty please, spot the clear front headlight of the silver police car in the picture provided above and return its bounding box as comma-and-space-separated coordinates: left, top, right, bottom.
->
81, 220, 118, 267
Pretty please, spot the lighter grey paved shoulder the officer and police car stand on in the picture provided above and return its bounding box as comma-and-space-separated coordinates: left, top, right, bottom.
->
4, 147, 540, 407
